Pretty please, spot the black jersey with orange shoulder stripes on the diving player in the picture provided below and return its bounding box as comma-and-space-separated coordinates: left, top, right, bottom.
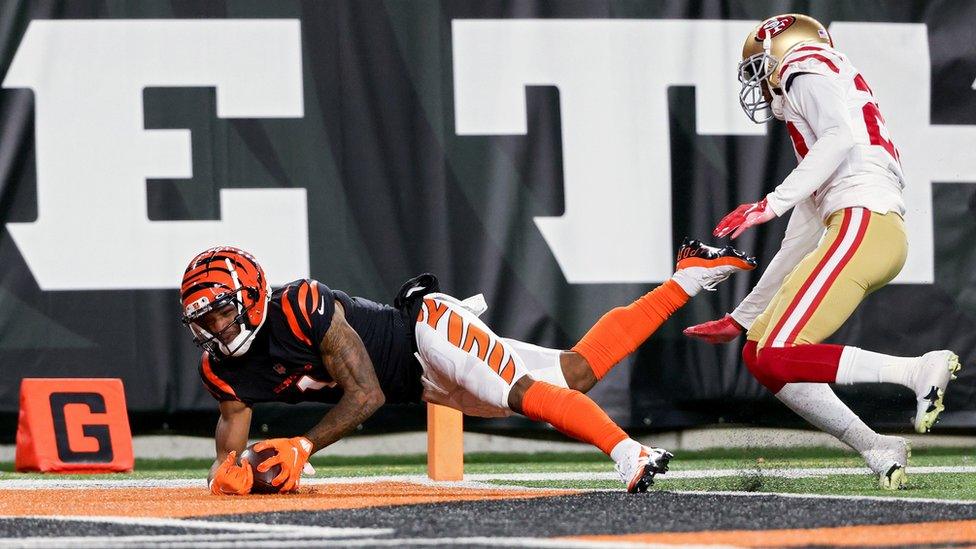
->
200, 280, 422, 405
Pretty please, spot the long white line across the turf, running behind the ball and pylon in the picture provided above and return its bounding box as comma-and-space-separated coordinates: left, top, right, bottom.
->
0, 465, 976, 490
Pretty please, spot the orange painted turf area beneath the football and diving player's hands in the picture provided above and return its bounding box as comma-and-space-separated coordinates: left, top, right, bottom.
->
0, 479, 579, 517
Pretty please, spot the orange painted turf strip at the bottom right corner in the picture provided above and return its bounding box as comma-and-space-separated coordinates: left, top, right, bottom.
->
565, 520, 976, 547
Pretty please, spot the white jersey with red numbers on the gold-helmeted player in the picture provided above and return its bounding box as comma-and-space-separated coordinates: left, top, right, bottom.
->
767, 44, 905, 220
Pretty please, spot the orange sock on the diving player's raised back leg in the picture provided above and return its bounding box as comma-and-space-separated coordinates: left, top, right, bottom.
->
573, 280, 688, 379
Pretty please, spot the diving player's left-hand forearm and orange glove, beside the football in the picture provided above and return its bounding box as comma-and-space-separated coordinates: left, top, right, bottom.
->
207, 400, 254, 495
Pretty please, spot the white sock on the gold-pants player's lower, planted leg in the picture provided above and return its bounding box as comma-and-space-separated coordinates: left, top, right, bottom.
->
776, 383, 881, 452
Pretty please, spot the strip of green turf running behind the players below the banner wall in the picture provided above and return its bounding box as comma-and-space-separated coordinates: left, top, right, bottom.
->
0, 448, 976, 500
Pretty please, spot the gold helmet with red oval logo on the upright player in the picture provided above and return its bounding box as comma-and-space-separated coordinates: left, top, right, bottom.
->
739, 13, 834, 124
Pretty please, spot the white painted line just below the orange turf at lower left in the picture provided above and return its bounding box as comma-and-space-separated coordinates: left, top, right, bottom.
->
0, 515, 393, 539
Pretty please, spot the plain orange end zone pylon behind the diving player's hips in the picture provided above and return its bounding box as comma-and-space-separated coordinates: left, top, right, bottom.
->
427, 402, 464, 480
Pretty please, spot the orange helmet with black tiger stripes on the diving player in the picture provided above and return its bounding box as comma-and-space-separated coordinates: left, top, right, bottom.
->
180, 246, 271, 359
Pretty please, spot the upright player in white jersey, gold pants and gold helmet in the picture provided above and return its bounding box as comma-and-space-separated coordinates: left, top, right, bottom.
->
685, 14, 959, 489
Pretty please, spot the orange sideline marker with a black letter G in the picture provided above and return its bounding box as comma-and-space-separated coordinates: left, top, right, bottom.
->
15, 378, 134, 473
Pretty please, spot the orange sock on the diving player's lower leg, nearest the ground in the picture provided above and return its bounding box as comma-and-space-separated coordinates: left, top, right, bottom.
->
522, 381, 630, 456
